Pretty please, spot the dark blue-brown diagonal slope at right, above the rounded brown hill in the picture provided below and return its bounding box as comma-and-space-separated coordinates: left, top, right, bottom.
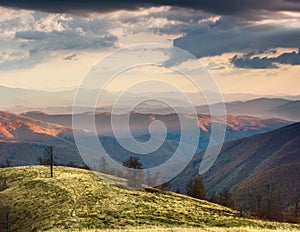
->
173, 123, 300, 206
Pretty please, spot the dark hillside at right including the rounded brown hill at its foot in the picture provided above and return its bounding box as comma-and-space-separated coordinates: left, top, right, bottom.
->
173, 123, 300, 219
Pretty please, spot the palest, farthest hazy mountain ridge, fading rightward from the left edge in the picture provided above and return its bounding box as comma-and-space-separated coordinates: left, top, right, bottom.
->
0, 86, 199, 110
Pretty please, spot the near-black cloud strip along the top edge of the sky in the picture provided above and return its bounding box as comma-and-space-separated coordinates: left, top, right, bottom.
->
0, 0, 300, 15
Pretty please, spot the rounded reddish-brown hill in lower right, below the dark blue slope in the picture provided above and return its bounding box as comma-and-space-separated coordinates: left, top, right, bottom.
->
231, 162, 300, 211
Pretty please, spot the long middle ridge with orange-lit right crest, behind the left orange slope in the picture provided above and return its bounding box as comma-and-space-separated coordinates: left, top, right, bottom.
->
22, 112, 290, 149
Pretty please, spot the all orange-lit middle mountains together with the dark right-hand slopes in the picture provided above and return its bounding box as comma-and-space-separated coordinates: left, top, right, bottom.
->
0, 108, 300, 220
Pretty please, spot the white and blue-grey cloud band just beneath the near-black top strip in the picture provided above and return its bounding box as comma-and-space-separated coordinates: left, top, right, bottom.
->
0, 6, 300, 72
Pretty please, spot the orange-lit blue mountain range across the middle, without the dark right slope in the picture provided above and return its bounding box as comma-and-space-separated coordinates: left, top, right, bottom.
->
0, 112, 290, 167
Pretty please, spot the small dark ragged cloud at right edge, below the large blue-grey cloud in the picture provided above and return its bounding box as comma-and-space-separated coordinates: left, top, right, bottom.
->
231, 49, 300, 69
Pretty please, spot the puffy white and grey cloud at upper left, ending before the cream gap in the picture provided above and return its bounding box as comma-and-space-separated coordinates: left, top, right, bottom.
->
0, 10, 118, 70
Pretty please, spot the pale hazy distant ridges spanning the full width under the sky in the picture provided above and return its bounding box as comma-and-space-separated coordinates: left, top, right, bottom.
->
0, 86, 300, 117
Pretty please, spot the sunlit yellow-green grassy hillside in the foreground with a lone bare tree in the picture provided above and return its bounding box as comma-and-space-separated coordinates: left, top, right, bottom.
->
0, 166, 300, 232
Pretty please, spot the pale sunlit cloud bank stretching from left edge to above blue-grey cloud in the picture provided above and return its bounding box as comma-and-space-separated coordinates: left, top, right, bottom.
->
0, 7, 220, 70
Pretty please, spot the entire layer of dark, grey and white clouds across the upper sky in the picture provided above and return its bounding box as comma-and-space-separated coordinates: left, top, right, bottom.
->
0, 0, 300, 70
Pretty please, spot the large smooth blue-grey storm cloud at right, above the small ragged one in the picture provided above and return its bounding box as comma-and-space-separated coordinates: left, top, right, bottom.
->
174, 25, 300, 58
